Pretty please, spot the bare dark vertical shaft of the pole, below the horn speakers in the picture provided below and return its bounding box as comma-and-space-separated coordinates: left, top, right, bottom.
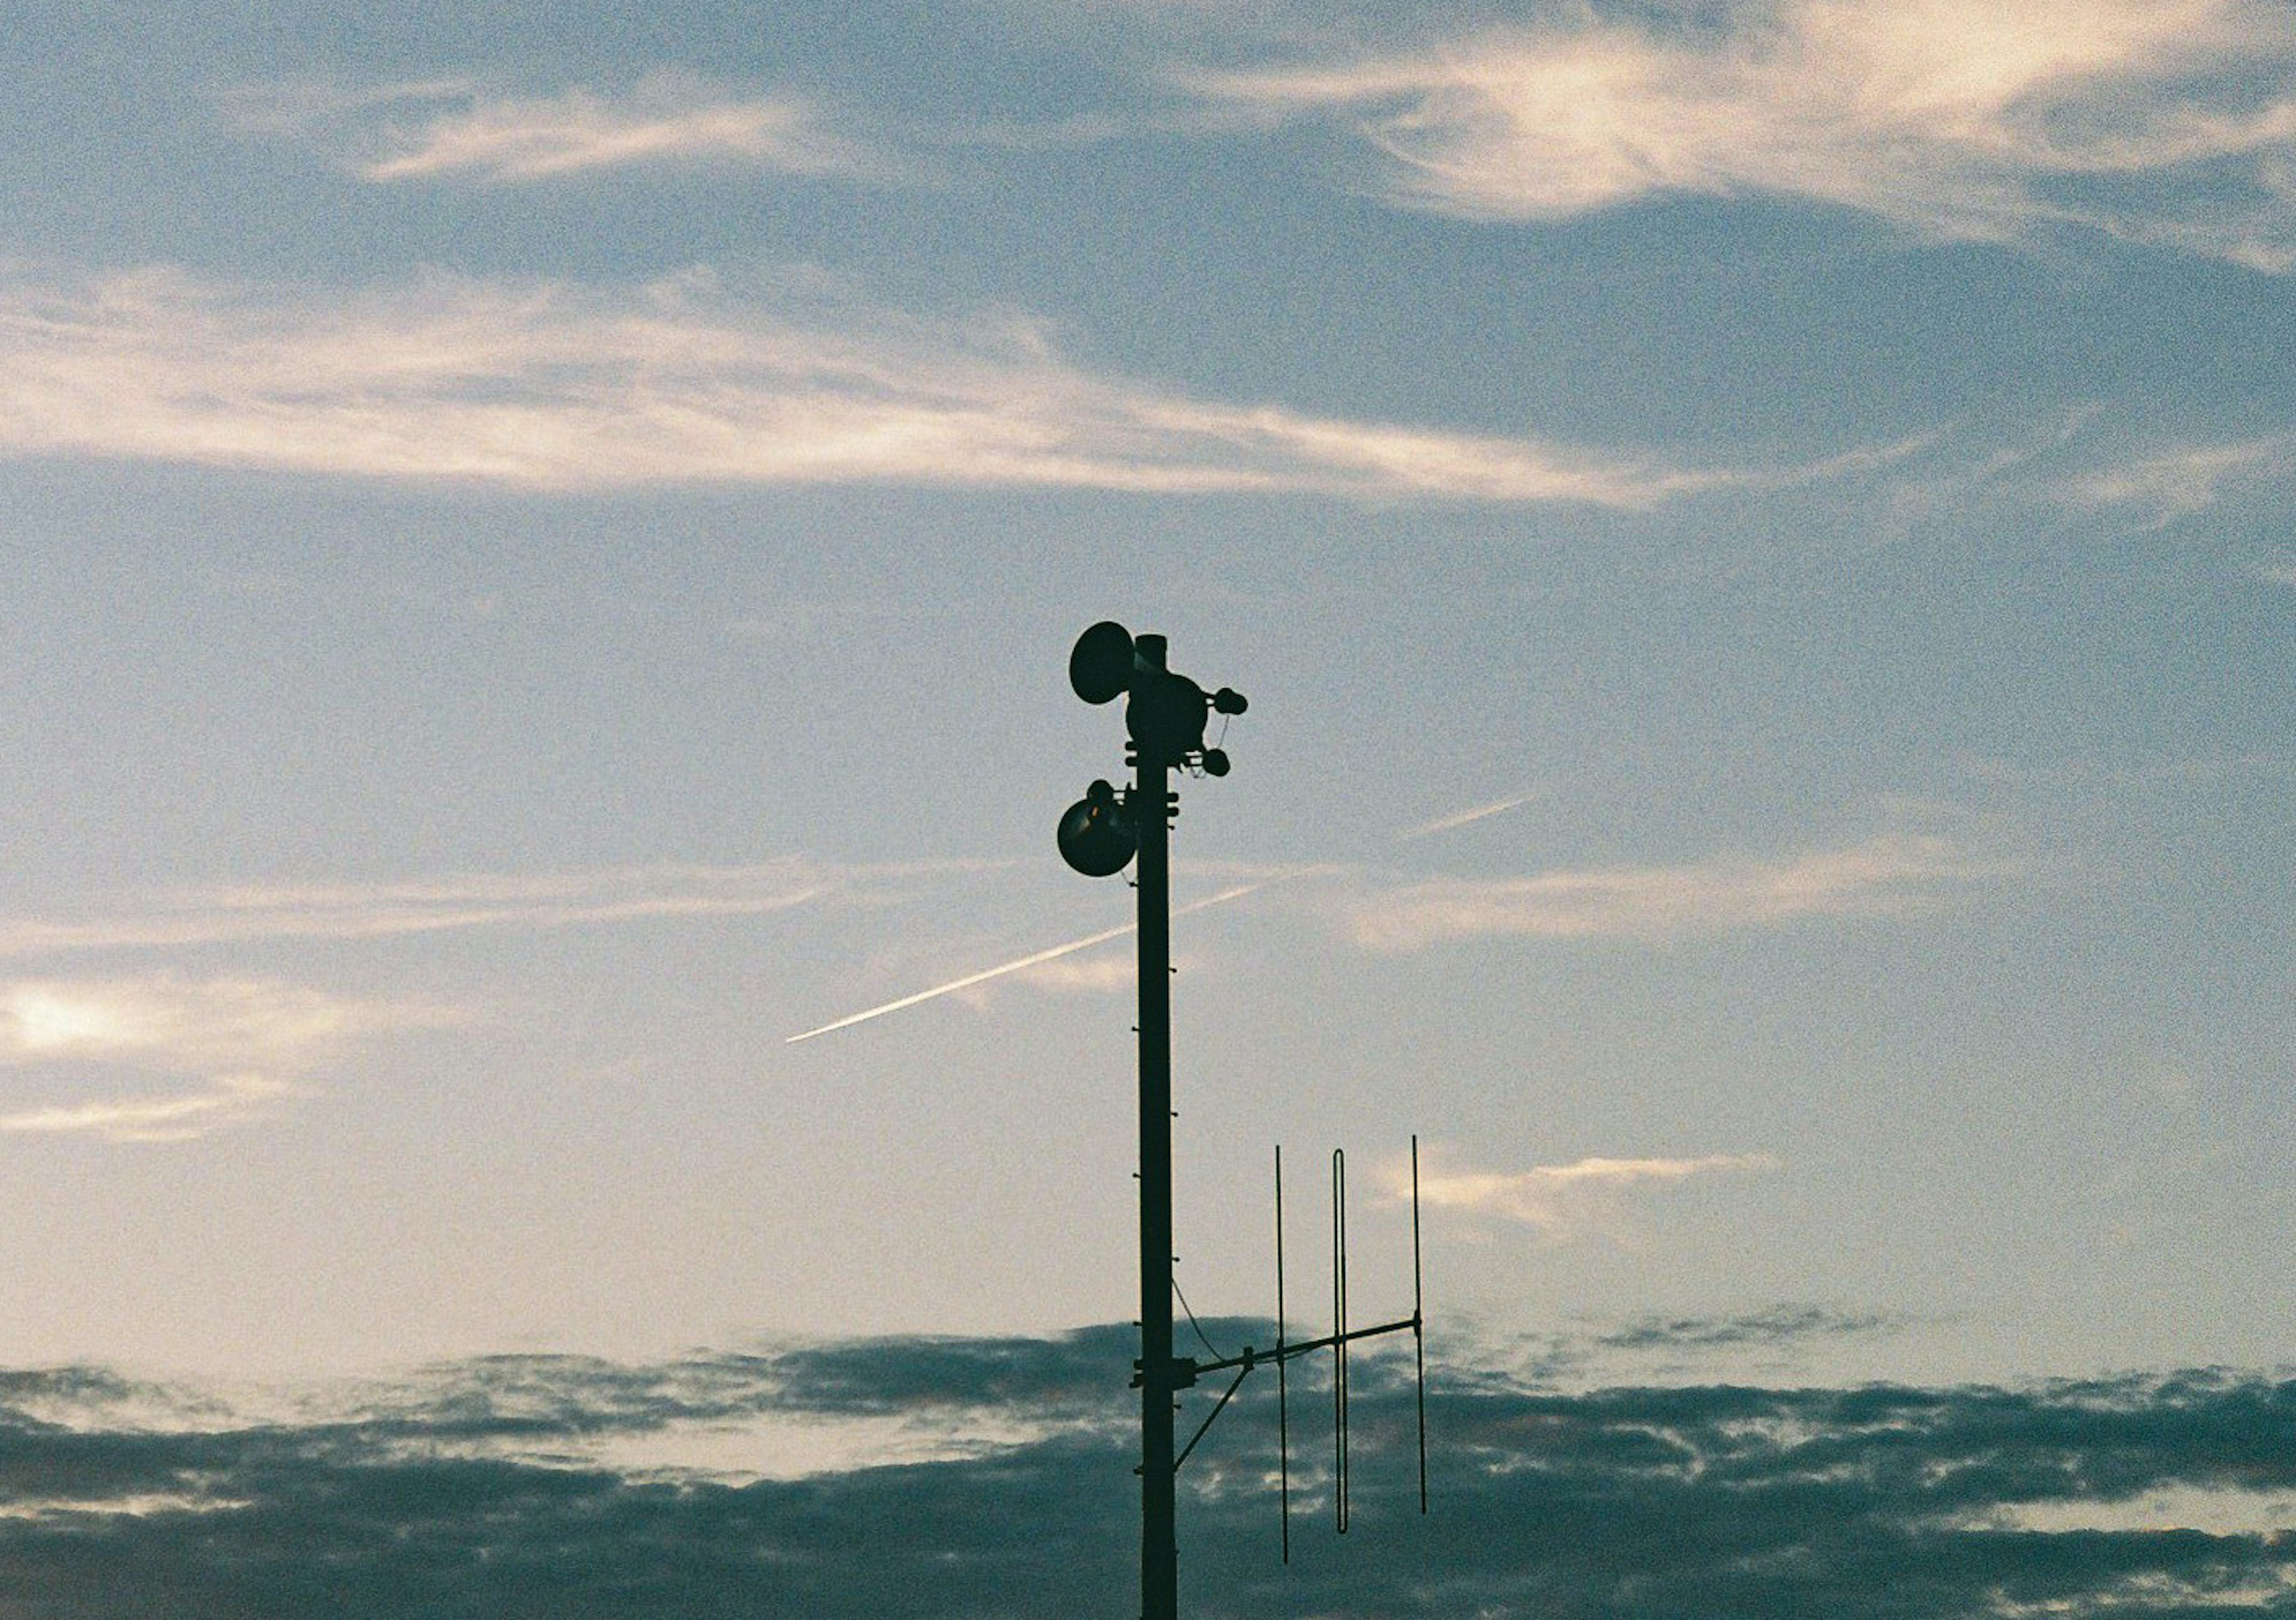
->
1137, 749, 1180, 1620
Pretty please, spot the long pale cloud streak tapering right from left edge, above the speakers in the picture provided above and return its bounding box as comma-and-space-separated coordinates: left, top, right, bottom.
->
0, 269, 1736, 508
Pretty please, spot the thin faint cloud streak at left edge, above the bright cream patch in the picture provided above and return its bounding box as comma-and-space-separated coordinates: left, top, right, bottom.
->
0, 859, 868, 958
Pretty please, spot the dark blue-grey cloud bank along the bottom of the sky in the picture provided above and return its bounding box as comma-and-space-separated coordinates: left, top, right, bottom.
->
0, 1323, 2296, 1620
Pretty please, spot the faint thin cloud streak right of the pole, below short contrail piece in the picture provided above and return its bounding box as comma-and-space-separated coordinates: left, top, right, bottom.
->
1348, 834, 2004, 951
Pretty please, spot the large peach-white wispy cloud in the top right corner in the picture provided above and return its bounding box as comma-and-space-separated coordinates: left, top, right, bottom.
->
1192, 0, 2296, 271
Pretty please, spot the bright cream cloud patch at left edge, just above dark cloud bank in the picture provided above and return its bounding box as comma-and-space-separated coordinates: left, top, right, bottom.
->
0, 974, 454, 1142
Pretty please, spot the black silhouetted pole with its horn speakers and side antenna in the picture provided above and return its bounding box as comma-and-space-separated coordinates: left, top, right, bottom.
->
1058, 620, 1426, 1620
